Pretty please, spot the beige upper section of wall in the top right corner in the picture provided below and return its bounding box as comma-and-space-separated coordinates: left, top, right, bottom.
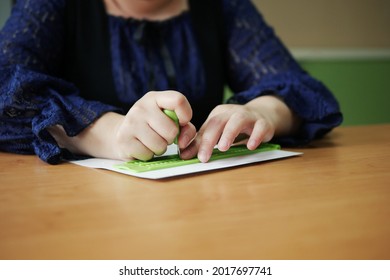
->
252, 0, 390, 49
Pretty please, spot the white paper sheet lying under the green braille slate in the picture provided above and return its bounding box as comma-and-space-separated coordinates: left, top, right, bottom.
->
71, 144, 302, 179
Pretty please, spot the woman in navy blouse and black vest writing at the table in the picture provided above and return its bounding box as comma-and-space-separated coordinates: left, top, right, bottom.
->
0, 0, 342, 163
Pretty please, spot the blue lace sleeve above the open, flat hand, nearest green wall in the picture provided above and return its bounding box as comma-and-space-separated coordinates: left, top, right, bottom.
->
224, 0, 342, 145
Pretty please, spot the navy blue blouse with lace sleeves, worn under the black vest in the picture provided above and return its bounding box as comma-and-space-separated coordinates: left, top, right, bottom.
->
0, 0, 342, 163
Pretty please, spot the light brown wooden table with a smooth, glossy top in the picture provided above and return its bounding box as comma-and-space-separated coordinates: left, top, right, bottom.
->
0, 124, 390, 259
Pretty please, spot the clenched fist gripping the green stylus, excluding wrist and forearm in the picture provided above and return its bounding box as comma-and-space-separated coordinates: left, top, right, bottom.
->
115, 91, 196, 160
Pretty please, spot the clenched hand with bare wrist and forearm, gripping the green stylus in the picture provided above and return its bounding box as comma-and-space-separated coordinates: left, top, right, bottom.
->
49, 91, 196, 160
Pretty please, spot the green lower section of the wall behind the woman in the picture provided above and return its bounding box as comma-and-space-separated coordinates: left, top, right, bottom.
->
300, 58, 390, 126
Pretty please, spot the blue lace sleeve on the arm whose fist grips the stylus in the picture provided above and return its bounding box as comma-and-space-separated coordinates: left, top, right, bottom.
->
0, 0, 119, 164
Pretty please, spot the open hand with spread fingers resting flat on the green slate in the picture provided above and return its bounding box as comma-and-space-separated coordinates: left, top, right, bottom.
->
181, 95, 300, 162
